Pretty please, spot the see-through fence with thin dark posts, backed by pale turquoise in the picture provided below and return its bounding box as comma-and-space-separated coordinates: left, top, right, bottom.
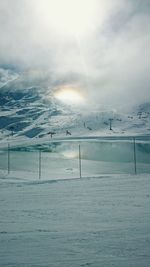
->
0, 138, 150, 179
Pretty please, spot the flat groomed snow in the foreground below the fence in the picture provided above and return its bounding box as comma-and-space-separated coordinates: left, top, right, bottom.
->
0, 171, 150, 267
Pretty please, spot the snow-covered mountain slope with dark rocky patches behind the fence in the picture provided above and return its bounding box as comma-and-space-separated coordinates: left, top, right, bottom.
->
0, 73, 150, 144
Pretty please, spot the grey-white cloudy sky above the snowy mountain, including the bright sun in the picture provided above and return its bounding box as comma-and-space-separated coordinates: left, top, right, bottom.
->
0, 0, 150, 108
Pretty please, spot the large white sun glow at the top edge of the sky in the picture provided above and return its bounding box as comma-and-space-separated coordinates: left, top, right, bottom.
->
36, 0, 97, 37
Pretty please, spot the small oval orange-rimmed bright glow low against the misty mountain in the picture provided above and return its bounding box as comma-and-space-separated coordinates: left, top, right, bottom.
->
54, 86, 85, 105
